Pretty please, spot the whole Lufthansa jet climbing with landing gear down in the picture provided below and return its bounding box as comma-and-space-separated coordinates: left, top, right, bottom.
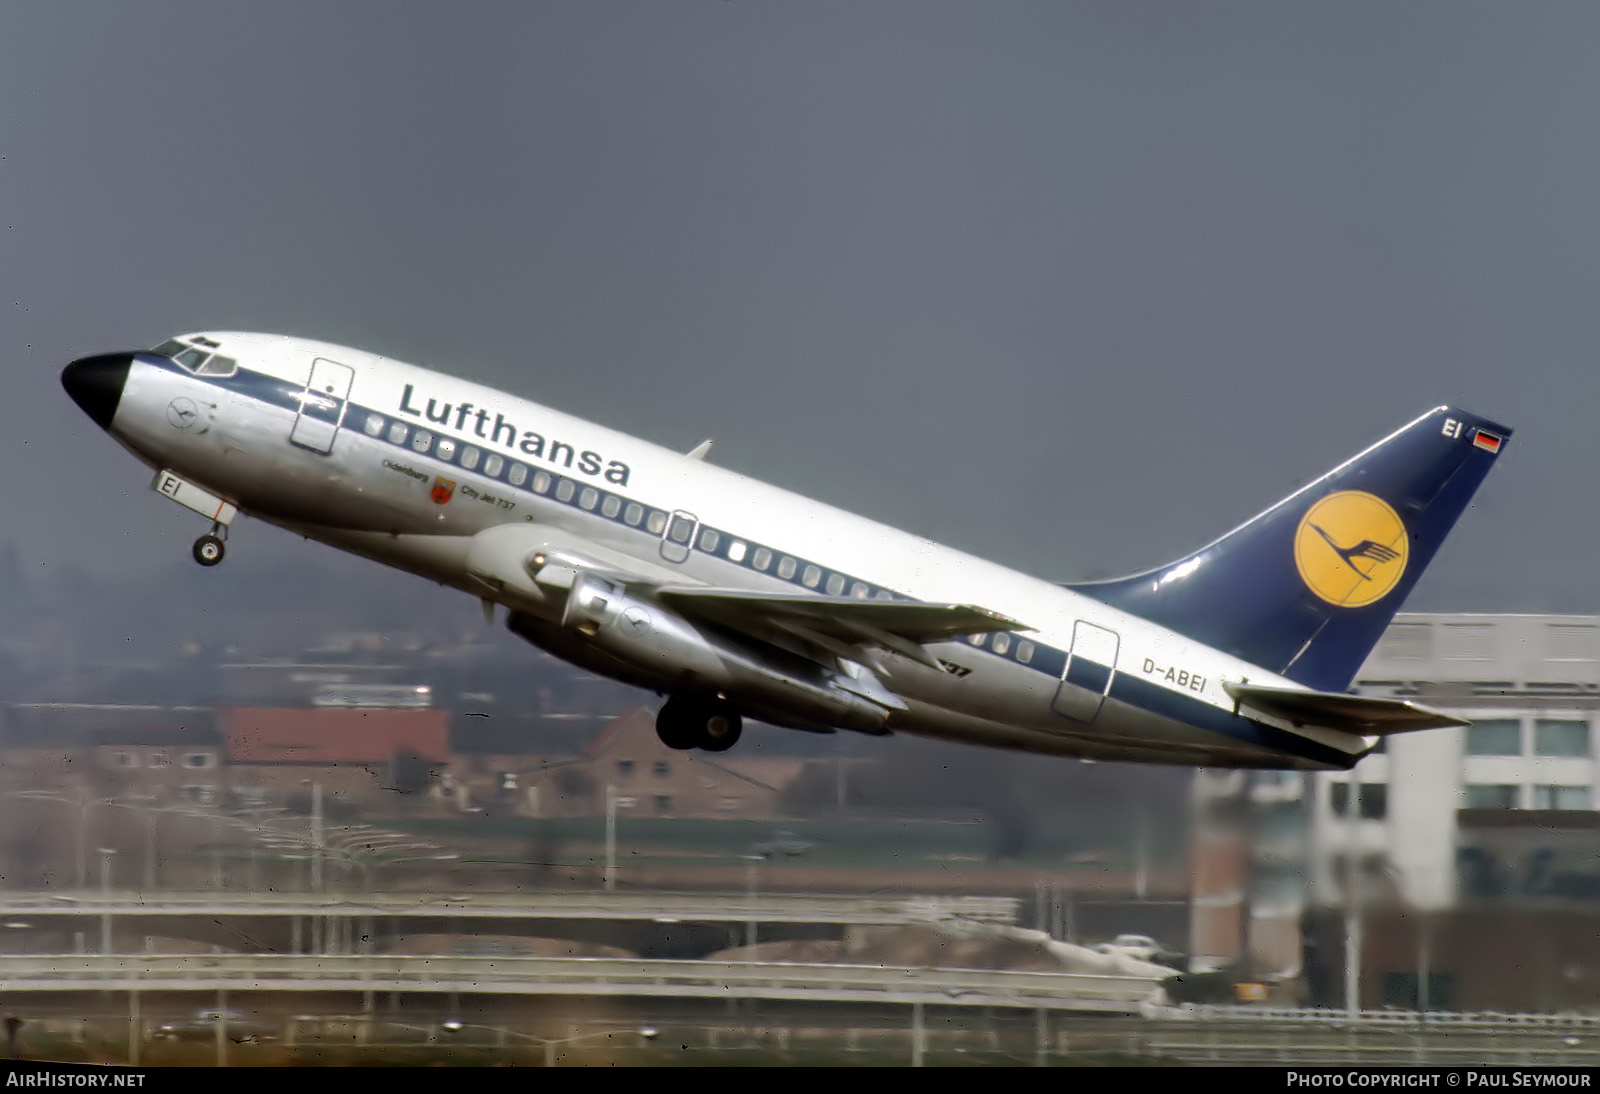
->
62, 331, 1510, 769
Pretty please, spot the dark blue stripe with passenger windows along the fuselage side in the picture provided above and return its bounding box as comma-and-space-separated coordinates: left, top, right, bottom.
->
138, 353, 1346, 763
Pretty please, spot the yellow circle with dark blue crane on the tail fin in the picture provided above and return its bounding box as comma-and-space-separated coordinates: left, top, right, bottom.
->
1294, 489, 1406, 608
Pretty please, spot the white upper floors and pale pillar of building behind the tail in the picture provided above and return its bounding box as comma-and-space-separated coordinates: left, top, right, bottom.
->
1307, 614, 1600, 908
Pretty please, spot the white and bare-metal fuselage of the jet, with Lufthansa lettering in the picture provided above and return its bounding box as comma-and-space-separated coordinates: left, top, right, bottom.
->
87, 333, 1368, 769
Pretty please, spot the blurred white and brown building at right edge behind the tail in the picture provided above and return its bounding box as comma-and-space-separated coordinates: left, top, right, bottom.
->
1306, 614, 1600, 1011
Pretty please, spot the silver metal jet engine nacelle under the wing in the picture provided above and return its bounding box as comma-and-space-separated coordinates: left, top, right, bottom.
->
562, 574, 890, 733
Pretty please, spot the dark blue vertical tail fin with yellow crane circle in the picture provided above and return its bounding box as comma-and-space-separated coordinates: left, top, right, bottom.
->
1067, 406, 1510, 691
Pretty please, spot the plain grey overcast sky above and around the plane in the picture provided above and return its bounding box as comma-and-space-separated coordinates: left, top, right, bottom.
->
0, 0, 1600, 611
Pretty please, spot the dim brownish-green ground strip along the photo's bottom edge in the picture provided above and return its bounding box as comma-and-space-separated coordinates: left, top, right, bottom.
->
15, 1008, 1600, 1067
